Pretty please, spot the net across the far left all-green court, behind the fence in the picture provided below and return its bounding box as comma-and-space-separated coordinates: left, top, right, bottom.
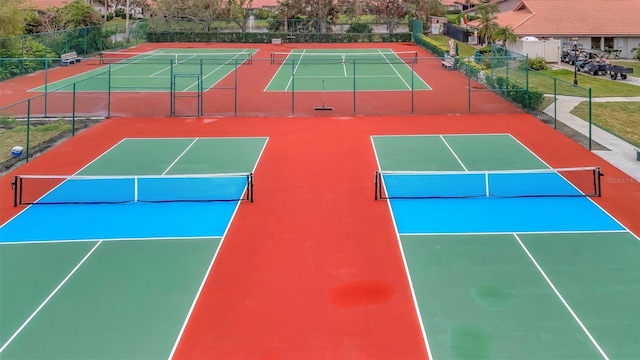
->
98, 51, 253, 65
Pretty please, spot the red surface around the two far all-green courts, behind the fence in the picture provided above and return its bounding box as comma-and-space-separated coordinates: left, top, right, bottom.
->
0, 43, 520, 117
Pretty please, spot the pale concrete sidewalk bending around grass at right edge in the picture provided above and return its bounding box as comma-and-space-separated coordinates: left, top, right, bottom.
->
544, 95, 640, 182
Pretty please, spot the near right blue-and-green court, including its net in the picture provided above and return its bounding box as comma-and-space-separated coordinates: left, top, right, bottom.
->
372, 134, 640, 359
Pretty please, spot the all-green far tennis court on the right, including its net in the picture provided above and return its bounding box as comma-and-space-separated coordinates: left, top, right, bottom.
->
265, 49, 431, 91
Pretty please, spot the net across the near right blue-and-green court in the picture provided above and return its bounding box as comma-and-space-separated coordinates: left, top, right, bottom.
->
375, 167, 602, 200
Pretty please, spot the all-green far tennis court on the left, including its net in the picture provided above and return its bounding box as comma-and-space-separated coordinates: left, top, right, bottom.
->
33, 49, 257, 92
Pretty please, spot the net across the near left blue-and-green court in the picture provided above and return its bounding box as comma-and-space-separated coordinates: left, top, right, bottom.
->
12, 173, 253, 206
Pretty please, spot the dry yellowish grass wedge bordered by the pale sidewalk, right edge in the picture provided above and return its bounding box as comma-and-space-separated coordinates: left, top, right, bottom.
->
571, 101, 640, 147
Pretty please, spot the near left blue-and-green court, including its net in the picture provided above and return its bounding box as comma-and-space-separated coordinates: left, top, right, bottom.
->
0, 138, 267, 359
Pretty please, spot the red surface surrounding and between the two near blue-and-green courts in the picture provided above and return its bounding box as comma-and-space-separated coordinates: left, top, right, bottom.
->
0, 113, 640, 359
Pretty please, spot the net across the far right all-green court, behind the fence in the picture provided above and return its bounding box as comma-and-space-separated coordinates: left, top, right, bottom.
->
270, 51, 418, 65
